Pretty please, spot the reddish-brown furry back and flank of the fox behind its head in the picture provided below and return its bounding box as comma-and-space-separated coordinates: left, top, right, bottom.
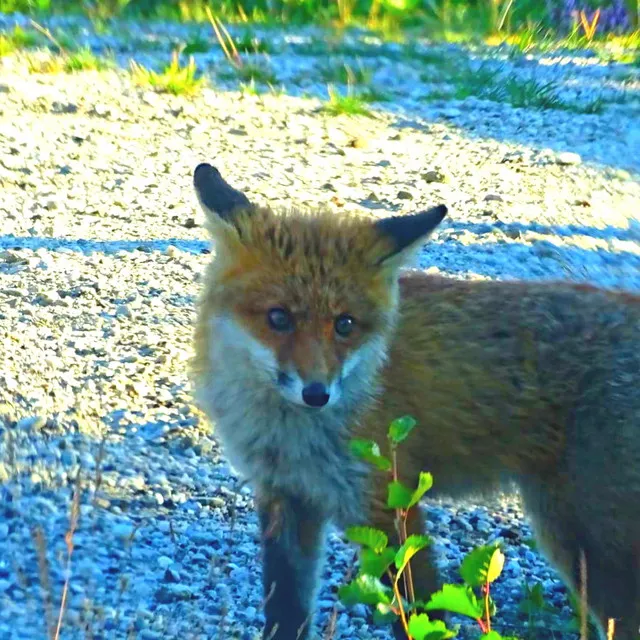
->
367, 272, 640, 492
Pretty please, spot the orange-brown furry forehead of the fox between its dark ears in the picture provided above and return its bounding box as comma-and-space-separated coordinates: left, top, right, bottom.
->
221, 211, 396, 316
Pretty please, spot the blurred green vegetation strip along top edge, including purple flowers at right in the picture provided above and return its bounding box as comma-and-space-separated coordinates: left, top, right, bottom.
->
0, 0, 640, 40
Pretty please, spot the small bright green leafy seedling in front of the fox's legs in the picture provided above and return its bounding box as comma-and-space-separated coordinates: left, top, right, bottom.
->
338, 416, 515, 640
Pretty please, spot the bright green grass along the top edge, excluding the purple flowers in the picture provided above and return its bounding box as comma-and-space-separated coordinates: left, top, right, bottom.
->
0, 0, 640, 51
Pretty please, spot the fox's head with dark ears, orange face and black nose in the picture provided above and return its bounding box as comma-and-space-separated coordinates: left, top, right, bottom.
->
194, 164, 447, 409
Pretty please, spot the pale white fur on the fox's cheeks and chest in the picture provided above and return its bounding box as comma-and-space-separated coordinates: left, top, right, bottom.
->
197, 317, 383, 526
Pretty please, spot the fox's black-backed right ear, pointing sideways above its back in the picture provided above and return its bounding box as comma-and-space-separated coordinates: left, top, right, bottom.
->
374, 204, 447, 266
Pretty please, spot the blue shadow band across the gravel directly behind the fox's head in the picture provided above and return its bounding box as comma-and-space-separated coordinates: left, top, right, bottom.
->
0, 230, 640, 289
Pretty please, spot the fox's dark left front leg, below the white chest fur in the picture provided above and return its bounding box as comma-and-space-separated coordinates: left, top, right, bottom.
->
258, 495, 324, 640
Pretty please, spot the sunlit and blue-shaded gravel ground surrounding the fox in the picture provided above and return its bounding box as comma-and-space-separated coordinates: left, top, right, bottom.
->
0, 12, 640, 640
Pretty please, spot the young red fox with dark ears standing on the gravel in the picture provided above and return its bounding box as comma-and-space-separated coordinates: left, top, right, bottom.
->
191, 163, 640, 640
